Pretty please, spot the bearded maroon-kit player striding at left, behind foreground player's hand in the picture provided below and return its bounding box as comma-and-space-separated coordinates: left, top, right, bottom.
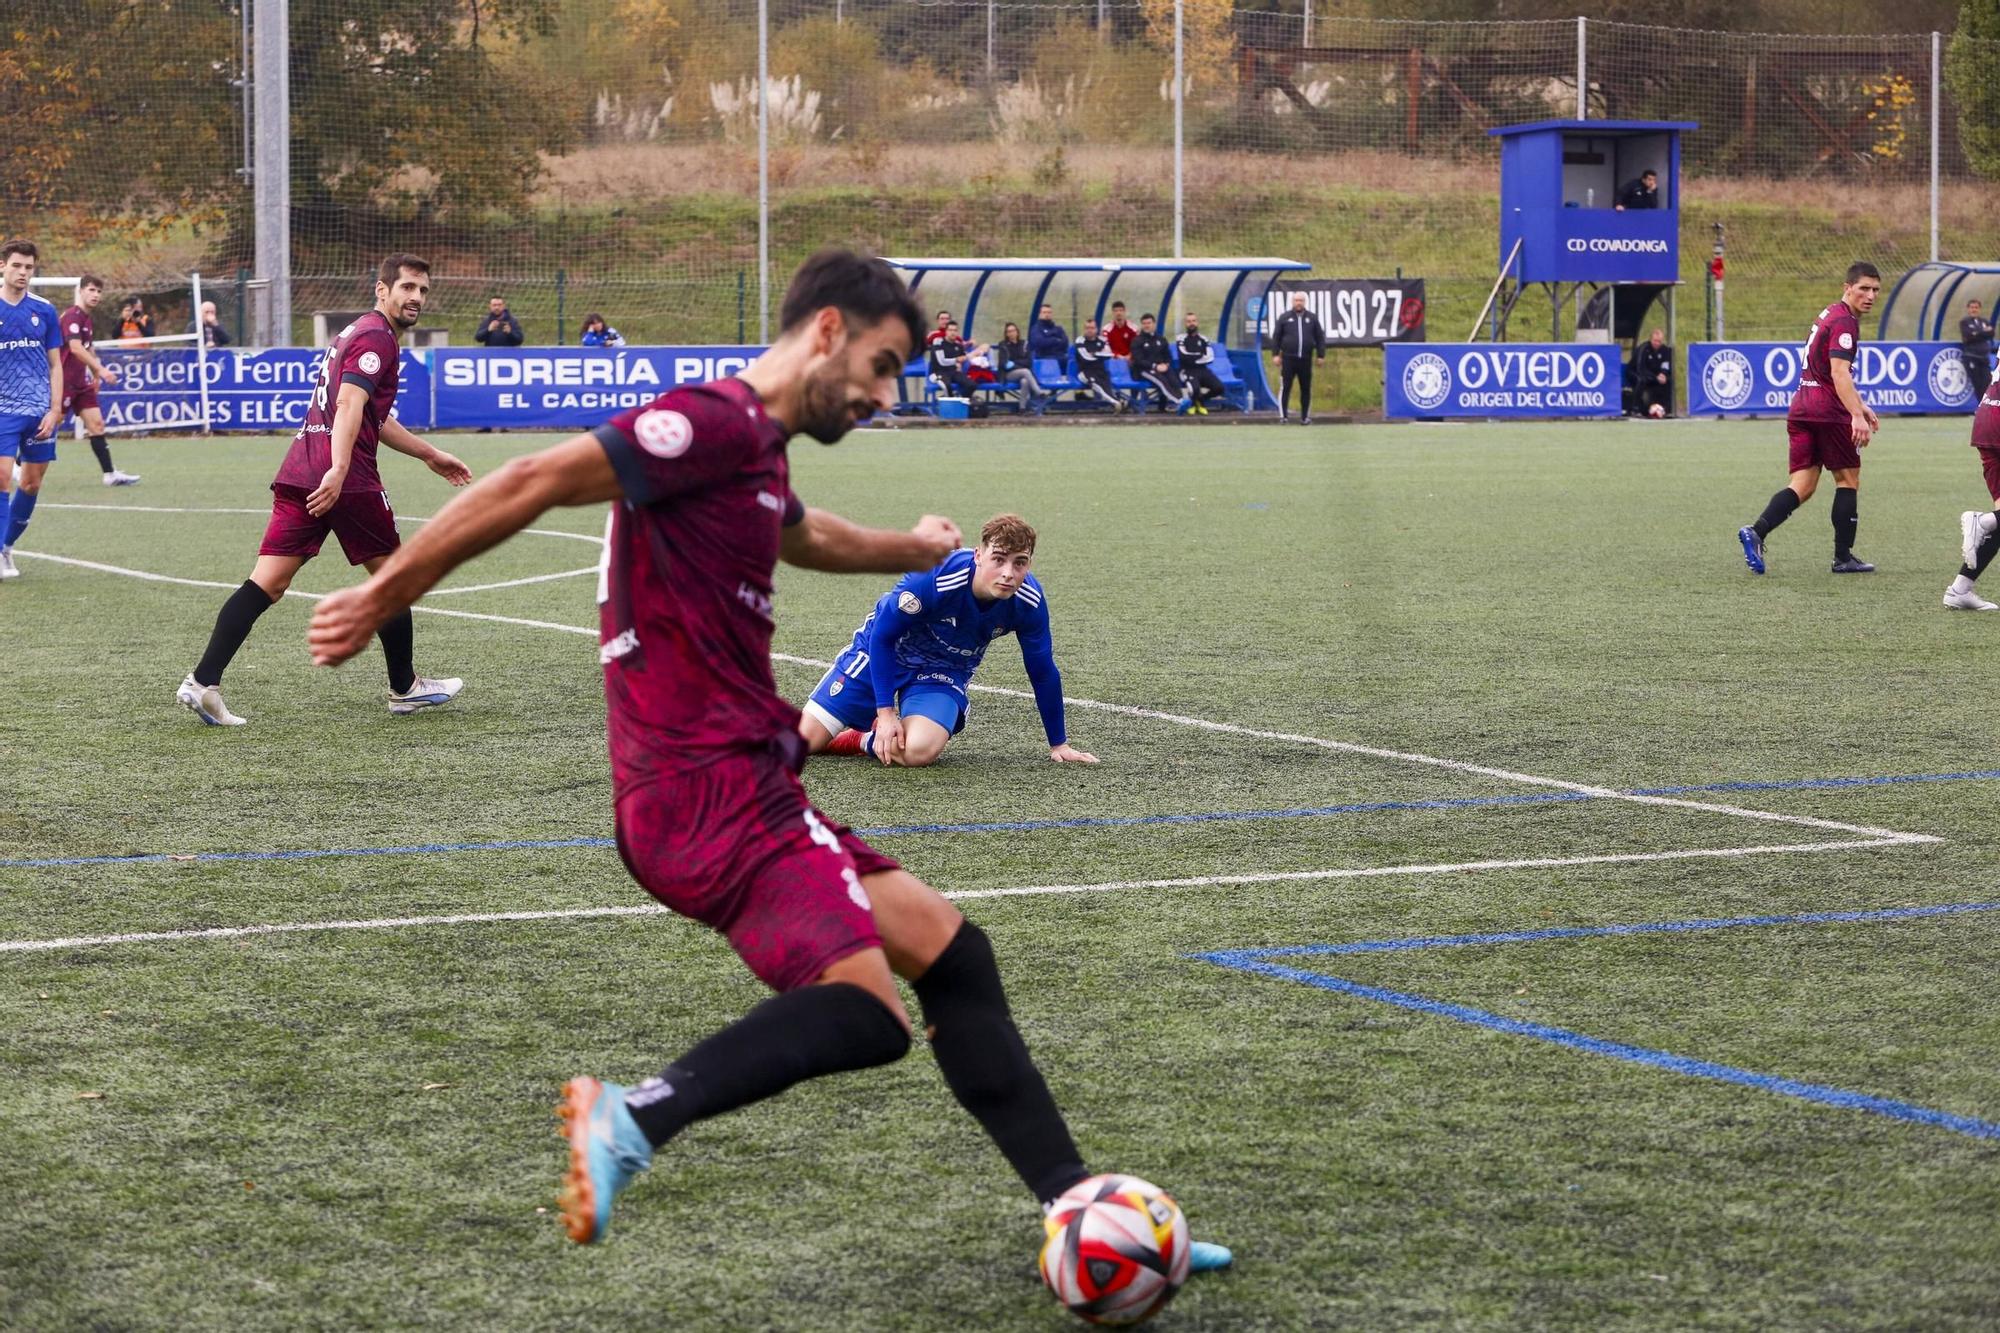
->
174, 254, 472, 727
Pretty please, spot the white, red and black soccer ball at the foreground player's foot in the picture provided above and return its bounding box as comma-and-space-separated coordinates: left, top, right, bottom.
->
1042, 1175, 1188, 1323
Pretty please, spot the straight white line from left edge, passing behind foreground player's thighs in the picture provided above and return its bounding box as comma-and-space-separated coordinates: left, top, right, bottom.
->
0, 839, 1906, 953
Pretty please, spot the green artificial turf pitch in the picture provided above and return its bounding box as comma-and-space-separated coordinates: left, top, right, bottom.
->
0, 420, 2000, 1329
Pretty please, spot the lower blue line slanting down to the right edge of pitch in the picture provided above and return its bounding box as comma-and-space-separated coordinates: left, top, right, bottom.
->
1196, 948, 2000, 1139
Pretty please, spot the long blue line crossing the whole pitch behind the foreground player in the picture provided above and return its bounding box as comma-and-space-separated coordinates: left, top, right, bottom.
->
0, 769, 2000, 871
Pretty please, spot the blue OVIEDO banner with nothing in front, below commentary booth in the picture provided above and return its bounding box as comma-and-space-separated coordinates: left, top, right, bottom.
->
1382, 342, 1624, 418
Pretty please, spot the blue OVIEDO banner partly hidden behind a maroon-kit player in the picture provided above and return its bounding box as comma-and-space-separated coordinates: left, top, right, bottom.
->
1688, 342, 1976, 416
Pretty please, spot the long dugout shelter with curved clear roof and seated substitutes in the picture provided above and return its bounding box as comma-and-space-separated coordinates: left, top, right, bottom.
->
886, 256, 1312, 410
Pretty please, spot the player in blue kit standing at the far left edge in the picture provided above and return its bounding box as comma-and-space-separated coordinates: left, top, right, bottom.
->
0, 240, 62, 578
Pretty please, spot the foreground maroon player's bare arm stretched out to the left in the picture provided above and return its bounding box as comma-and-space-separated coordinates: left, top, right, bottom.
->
306, 434, 620, 667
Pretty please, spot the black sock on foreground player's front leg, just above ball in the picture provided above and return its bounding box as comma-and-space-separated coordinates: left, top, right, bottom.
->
912, 921, 1088, 1205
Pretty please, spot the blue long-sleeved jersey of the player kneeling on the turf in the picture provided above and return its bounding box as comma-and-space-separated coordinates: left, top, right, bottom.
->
836, 550, 1068, 747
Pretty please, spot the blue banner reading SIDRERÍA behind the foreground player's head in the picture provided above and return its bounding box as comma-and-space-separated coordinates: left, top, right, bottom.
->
430, 346, 764, 430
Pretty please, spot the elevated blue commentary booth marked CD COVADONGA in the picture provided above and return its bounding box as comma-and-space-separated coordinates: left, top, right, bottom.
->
1474, 120, 1696, 340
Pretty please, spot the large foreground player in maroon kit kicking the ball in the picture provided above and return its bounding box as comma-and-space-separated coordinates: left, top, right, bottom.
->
308, 250, 1228, 1267
